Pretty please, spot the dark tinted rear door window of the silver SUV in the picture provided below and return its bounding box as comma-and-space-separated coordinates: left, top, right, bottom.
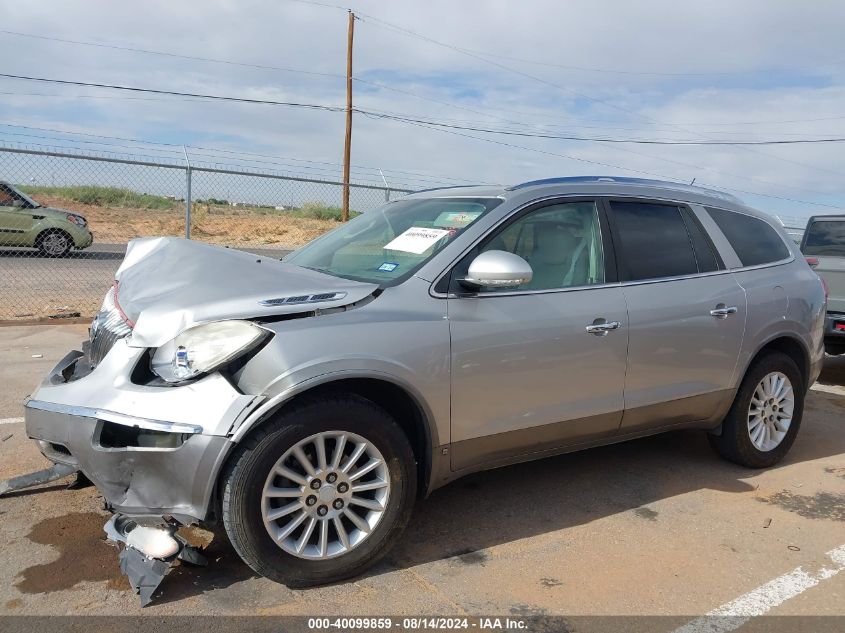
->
610, 201, 699, 281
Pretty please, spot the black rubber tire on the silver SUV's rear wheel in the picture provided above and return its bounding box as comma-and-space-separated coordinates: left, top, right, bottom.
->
708, 352, 806, 468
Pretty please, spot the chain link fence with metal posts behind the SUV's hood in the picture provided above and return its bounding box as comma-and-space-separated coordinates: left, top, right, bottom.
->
0, 147, 409, 321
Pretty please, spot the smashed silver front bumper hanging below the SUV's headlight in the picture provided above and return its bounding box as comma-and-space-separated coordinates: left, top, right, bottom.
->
25, 340, 262, 524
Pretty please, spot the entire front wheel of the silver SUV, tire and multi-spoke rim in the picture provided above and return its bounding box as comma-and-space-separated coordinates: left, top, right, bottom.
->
223, 395, 416, 587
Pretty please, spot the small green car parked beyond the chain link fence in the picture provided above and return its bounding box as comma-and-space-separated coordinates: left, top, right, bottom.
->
0, 180, 94, 257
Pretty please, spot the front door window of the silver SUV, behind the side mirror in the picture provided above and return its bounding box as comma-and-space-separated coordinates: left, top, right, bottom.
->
453, 201, 605, 292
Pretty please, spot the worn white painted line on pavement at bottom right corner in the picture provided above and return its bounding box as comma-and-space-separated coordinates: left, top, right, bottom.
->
674, 545, 845, 633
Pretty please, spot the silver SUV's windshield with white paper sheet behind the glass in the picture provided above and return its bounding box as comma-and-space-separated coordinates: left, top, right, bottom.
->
284, 198, 502, 286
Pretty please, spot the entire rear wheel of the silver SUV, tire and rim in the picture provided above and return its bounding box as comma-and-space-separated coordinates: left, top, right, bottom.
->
709, 352, 805, 468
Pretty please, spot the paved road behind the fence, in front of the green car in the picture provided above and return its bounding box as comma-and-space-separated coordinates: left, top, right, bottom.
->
0, 243, 290, 321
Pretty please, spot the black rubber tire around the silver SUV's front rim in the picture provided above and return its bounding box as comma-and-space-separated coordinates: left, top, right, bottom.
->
221, 394, 417, 588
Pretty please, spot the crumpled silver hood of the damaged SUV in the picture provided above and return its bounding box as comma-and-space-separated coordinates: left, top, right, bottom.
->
115, 237, 378, 347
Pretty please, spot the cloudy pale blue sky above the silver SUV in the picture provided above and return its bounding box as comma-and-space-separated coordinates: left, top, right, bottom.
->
0, 0, 845, 218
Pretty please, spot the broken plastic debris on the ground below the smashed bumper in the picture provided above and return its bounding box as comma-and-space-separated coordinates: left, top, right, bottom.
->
103, 514, 208, 607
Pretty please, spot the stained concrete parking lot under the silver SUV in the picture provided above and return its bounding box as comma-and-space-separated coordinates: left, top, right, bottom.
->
0, 325, 845, 628
